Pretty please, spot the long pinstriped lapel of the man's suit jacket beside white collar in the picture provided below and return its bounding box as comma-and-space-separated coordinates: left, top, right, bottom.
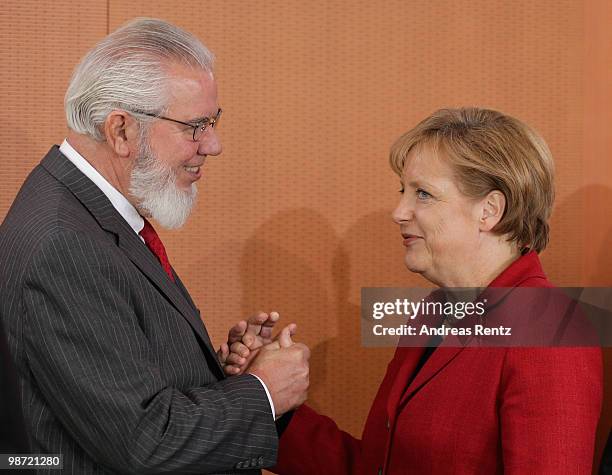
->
41, 146, 223, 377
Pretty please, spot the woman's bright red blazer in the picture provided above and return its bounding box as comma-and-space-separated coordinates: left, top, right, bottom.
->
273, 252, 603, 475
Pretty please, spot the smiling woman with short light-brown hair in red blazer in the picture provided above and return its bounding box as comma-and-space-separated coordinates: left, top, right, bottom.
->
227, 108, 603, 475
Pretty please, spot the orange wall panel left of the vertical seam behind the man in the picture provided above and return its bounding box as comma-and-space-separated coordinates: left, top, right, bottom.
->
0, 0, 107, 218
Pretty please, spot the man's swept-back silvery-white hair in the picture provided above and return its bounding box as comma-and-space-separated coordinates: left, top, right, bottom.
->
64, 18, 214, 141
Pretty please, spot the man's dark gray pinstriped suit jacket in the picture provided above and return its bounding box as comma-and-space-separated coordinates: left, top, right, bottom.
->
0, 146, 278, 474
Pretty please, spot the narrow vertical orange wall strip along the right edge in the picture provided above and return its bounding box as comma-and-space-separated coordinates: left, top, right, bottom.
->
573, 0, 612, 468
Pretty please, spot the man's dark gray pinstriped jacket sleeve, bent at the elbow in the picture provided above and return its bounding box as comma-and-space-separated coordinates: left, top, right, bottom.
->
22, 231, 278, 474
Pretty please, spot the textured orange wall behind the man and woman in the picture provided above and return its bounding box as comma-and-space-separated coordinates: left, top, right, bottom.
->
0, 0, 612, 472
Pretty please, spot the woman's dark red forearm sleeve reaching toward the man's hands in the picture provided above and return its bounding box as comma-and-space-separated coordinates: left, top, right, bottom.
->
270, 405, 362, 475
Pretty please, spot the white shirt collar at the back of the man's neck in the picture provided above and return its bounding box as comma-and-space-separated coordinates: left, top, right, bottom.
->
60, 139, 144, 234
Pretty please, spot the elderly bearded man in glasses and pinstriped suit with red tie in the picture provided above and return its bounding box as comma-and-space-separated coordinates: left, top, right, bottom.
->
0, 19, 308, 474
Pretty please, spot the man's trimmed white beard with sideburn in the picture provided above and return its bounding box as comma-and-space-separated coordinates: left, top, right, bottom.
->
130, 137, 198, 229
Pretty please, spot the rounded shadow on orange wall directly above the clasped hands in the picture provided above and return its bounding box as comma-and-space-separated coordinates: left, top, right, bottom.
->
240, 209, 338, 412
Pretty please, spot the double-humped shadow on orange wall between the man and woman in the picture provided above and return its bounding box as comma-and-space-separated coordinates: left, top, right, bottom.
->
240, 209, 429, 436
